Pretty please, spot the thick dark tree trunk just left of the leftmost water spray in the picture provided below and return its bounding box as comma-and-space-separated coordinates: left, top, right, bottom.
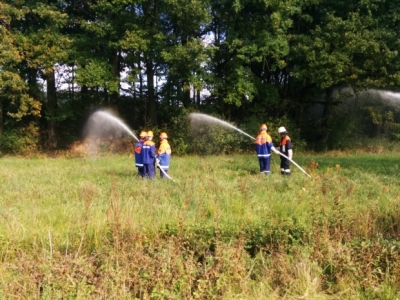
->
46, 69, 57, 149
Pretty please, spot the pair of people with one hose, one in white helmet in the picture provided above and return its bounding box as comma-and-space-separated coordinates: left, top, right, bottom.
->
255, 124, 293, 175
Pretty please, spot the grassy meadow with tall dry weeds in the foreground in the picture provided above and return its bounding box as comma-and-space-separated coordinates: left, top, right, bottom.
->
0, 153, 400, 299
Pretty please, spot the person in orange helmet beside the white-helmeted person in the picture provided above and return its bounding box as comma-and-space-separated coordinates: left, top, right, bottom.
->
255, 124, 277, 175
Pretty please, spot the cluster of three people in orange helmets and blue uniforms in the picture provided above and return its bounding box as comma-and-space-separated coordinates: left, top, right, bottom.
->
135, 130, 171, 179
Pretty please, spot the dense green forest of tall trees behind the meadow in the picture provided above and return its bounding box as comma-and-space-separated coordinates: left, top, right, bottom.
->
0, 0, 400, 153
